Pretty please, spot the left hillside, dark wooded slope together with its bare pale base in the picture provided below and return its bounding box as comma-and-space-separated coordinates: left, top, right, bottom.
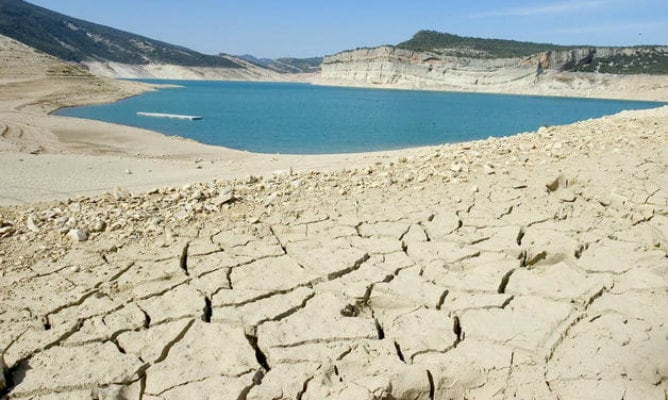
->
0, 0, 280, 80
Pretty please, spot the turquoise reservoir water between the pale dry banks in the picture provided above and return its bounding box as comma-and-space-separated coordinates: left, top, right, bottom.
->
57, 80, 662, 154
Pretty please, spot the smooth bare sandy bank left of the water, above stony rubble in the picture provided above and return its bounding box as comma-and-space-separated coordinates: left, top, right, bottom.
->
0, 75, 664, 205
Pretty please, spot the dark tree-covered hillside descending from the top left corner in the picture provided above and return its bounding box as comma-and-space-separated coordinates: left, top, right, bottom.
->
0, 0, 245, 69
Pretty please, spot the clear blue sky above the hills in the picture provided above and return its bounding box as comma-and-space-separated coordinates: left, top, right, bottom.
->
29, 0, 668, 58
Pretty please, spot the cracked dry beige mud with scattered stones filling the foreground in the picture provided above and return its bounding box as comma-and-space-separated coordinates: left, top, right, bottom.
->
0, 108, 668, 400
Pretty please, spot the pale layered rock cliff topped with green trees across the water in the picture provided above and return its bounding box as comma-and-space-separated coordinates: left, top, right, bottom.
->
318, 41, 668, 100
